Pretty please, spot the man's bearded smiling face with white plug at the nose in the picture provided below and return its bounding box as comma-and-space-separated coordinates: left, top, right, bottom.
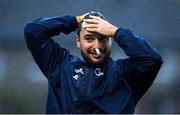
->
77, 28, 112, 65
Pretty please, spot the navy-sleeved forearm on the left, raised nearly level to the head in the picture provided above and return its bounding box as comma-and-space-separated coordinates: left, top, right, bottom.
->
24, 16, 78, 39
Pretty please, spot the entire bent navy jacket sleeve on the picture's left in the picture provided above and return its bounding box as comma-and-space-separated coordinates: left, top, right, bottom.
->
24, 16, 78, 77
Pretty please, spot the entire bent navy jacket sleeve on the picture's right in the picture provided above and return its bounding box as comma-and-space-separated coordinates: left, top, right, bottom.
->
114, 28, 162, 101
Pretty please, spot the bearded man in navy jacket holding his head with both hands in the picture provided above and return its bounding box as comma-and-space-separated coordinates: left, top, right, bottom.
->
24, 12, 162, 113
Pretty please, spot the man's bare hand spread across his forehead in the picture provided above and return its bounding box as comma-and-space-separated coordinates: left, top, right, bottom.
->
82, 16, 118, 37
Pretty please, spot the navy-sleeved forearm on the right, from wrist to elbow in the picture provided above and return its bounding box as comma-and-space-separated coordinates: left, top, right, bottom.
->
114, 28, 159, 57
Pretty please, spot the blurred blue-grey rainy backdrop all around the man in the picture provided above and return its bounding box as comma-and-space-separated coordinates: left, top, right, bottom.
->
0, 0, 180, 113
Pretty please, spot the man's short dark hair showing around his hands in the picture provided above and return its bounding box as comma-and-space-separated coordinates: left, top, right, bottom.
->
76, 11, 105, 37
